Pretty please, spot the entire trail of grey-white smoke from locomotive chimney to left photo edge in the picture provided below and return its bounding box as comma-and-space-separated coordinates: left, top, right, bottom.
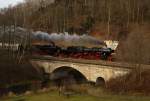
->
0, 26, 105, 47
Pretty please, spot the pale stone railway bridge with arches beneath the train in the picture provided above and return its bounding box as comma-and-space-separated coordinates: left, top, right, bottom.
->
31, 56, 149, 82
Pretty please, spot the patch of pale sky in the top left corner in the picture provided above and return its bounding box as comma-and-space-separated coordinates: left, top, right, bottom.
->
0, 0, 24, 8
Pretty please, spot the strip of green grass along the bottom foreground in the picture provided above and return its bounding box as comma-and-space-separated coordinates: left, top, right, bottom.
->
0, 91, 150, 101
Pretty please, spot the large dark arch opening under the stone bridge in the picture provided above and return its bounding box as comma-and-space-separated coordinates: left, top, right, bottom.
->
50, 66, 87, 83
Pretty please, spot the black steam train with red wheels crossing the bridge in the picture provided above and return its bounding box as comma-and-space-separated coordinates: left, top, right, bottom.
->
32, 44, 114, 61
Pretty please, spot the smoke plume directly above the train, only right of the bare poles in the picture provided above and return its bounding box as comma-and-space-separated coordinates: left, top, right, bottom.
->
33, 31, 105, 47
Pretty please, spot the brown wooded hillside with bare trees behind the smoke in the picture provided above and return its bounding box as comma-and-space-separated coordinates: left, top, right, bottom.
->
0, 0, 150, 40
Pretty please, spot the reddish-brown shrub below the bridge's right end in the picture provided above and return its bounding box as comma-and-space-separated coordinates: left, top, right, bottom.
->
107, 70, 150, 94
